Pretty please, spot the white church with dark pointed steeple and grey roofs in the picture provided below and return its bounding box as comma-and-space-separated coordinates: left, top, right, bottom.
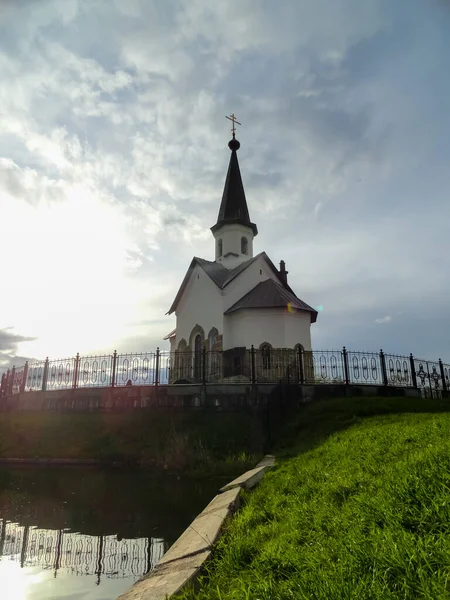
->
164, 128, 317, 380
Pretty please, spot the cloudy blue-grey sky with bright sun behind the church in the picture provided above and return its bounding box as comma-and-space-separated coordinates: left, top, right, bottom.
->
0, 0, 450, 370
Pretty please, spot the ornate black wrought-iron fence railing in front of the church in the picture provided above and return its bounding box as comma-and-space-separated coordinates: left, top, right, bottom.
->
0, 346, 450, 397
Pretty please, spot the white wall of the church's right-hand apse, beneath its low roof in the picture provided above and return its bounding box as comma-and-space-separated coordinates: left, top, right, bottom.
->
223, 308, 311, 350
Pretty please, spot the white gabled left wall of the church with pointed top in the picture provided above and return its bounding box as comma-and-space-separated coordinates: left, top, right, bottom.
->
175, 265, 223, 346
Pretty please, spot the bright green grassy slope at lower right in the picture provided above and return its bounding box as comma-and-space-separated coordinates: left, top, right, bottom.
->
180, 398, 450, 600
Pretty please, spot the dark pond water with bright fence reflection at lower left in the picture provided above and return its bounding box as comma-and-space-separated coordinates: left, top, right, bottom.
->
0, 466, 223, 600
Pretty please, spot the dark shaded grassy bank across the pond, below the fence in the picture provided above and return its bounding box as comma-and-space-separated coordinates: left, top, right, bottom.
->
0, 408, 264, 472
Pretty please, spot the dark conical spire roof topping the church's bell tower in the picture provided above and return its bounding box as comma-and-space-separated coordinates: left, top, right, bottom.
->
211, 136, 258, 235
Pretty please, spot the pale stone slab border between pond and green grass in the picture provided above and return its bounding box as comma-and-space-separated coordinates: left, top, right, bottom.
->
118, 455, 275, 600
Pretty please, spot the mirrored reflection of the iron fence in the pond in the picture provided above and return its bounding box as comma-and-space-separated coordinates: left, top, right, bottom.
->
0, 519, 167, 584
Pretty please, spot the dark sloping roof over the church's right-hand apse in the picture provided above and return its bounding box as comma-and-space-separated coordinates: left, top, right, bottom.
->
224, 279, 317, 323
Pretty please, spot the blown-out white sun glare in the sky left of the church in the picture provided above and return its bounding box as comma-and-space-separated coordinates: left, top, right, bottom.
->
0, 186, 146, 357
